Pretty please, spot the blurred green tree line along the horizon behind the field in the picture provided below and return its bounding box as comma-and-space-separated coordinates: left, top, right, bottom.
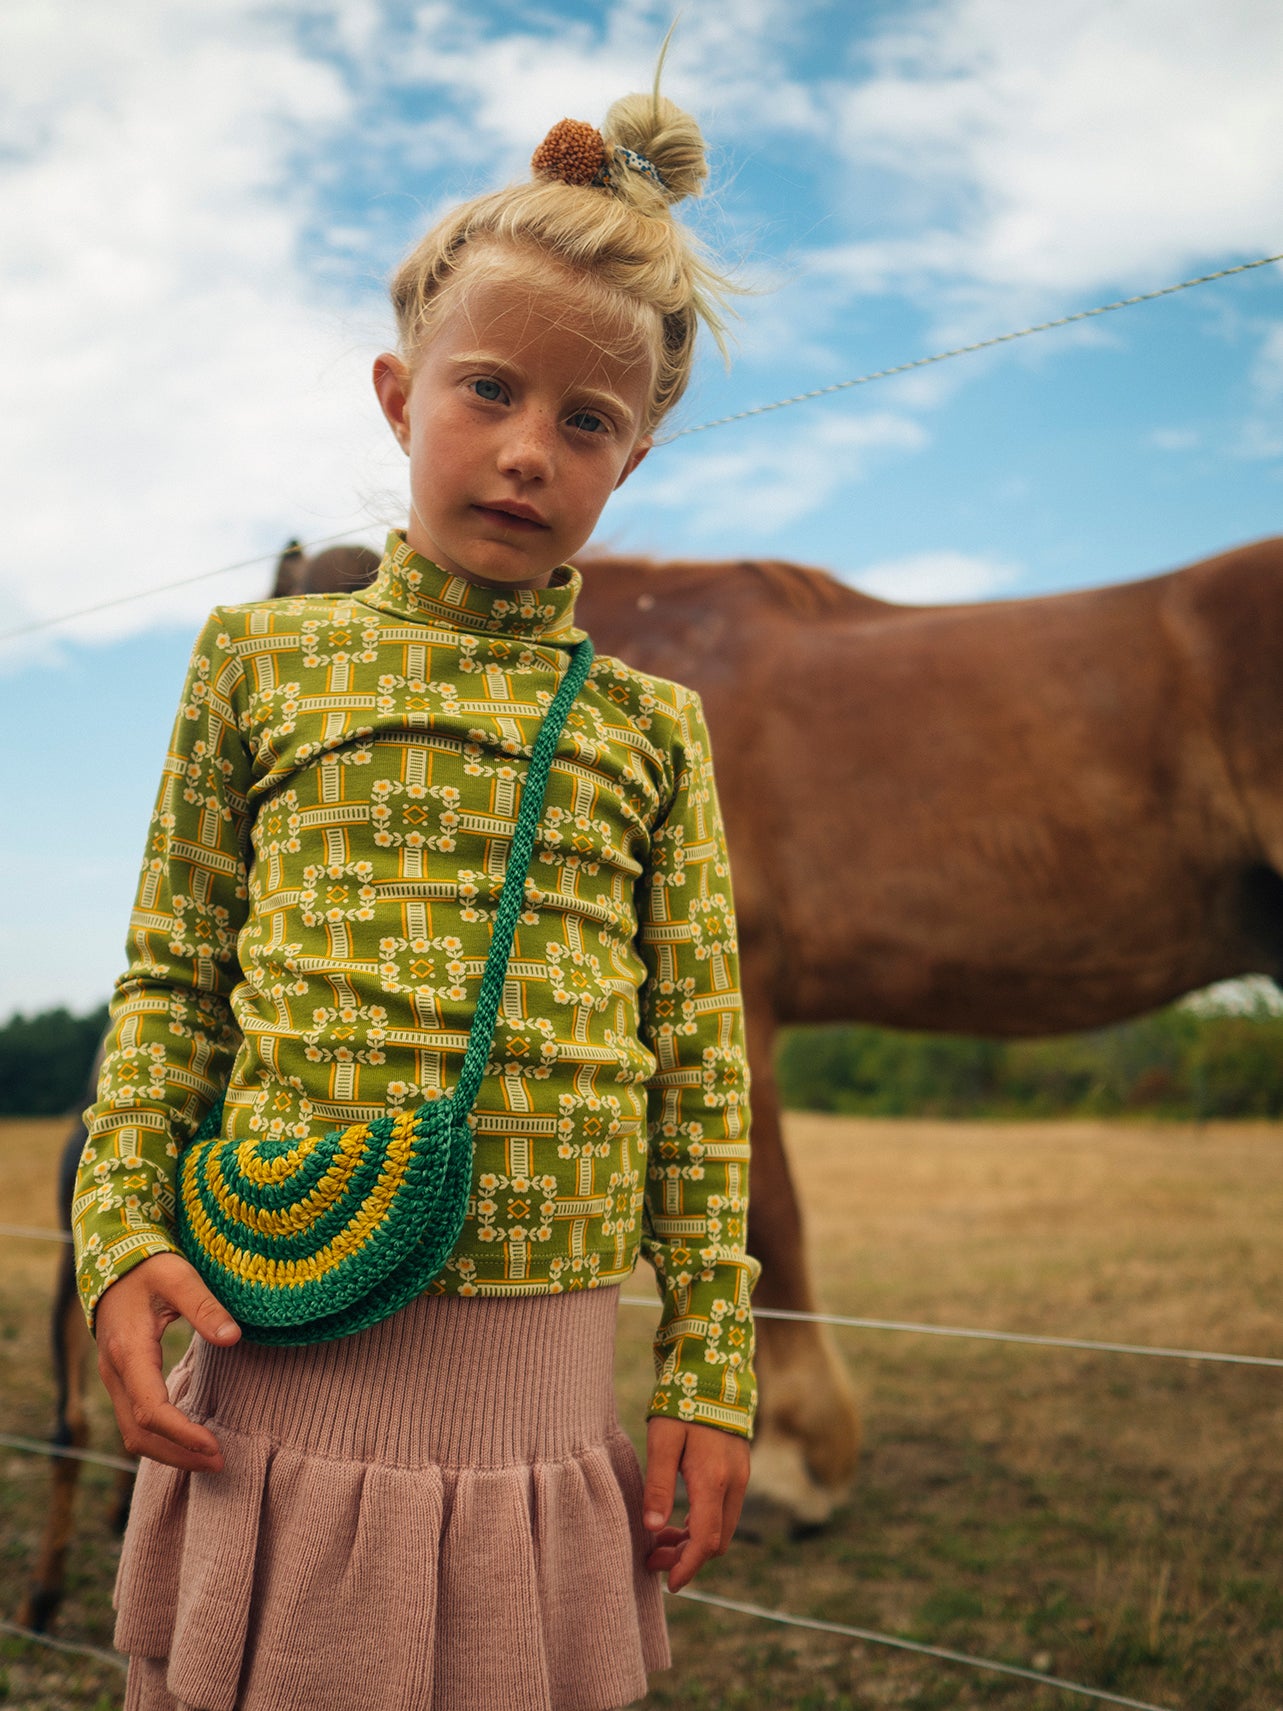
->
0, 999, 1283, 1121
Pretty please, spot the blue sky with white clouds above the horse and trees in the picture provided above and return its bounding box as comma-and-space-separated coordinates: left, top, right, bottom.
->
0, 0, 1283, 1016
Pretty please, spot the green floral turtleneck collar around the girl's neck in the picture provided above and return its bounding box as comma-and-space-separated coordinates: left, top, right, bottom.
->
358, 529, 587, 645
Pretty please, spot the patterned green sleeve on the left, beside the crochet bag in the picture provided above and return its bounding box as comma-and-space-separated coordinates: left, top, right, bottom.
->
72, 611, 251, 1319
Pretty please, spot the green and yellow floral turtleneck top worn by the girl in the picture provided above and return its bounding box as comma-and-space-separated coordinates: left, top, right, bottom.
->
74, 534, 758, 1434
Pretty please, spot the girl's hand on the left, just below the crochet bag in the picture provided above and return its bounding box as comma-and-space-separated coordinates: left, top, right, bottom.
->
94, 1254, 241, 1473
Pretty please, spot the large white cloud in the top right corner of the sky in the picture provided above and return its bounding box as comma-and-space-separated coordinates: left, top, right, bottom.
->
817, 0, 1283, 315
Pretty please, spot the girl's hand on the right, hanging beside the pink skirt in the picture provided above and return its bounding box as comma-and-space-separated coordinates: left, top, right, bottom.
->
642, 1417, 749, 1593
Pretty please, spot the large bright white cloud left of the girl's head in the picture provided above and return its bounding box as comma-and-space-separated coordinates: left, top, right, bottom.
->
0, 0, 407, 633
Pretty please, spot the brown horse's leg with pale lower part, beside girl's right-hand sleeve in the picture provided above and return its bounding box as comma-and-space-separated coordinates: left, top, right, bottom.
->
746, 1003, 860, 1526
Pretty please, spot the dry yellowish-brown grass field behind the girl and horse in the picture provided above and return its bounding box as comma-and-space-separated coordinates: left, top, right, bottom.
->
0, 1116, 1283, 1711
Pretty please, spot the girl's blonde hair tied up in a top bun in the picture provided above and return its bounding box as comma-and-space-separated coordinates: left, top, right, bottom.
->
390, 76, 737, 433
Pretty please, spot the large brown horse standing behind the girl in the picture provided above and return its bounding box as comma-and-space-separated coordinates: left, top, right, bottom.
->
277, 539, 1283, 1521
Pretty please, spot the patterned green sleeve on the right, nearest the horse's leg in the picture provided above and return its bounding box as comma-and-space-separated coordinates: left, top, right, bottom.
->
638, 691, 760, 1436
